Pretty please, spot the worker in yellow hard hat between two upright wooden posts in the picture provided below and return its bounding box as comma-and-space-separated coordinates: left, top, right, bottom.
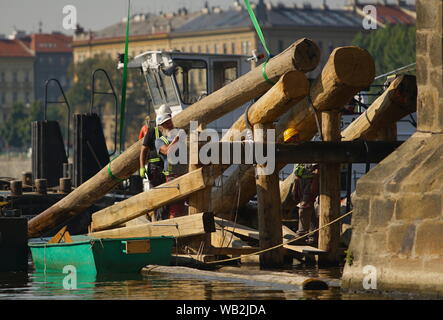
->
283, 128, 319, 244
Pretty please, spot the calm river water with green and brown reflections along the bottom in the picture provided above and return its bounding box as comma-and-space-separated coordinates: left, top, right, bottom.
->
0, 262, 390, 300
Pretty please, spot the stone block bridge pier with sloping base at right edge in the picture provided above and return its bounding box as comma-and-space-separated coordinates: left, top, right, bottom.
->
342, 0, 443, 298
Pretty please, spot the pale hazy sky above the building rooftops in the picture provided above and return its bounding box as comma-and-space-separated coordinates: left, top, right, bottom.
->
0, 0, 413, 35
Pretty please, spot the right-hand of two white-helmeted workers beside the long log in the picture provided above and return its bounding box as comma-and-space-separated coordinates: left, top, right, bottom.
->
155, 114, 185, 219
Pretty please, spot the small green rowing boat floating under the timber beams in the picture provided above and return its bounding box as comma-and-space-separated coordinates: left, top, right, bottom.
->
29, 236, 174, 274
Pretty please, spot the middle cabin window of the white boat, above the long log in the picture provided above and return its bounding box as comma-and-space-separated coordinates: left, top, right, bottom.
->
174, 59, 208, 104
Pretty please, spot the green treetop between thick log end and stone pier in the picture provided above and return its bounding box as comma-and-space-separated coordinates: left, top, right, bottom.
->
352, 24, 416, 75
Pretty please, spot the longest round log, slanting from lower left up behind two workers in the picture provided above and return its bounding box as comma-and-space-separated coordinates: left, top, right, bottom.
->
28, 38, 320, 237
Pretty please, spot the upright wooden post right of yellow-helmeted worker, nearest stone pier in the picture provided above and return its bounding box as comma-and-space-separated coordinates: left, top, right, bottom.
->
318, 110, 341, 265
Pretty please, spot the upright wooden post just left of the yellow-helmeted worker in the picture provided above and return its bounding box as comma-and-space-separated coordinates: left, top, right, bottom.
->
254, 124, 283, 268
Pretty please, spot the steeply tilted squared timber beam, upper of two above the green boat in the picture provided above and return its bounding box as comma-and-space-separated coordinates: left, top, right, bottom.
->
91, 168, 216, 231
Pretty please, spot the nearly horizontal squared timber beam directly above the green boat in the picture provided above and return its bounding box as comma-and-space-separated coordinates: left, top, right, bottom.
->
89, 212, 215, 239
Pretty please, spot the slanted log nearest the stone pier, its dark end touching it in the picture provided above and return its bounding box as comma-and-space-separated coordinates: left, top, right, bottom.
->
341, 75, 417, 141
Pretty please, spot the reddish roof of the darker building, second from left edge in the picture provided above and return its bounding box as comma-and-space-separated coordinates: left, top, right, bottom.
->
29, 33, 72, 53
